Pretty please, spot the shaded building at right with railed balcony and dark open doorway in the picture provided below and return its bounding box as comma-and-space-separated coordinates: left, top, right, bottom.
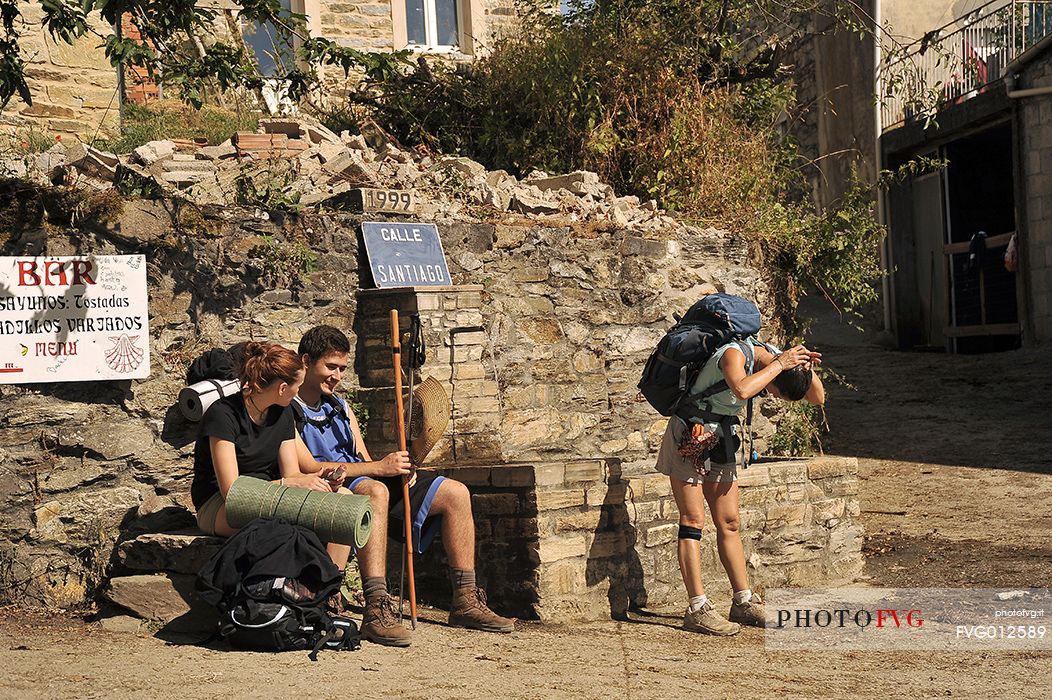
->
790, 0, 1052, 353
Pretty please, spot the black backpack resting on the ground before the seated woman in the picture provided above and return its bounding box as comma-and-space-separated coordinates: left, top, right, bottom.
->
197, 518, 361, 661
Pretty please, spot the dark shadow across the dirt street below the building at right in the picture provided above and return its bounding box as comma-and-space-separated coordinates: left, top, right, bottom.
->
802, 292, 1052, 474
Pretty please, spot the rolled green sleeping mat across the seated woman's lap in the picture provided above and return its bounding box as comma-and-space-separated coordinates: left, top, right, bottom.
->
226, 477, 372, 549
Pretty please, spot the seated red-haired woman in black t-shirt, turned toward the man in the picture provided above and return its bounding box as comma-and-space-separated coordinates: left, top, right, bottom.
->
190, 342, 332, 537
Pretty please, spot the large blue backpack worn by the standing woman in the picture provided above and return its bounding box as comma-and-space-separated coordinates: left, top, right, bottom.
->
639, 294, 761, 416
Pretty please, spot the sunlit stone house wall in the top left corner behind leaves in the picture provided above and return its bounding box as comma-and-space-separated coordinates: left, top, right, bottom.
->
0, 0, 120, 138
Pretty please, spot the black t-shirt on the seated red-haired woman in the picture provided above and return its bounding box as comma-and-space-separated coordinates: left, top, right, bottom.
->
190, 393, 296, 508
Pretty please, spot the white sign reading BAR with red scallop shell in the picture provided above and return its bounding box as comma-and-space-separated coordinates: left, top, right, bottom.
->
0, 255, 149, 384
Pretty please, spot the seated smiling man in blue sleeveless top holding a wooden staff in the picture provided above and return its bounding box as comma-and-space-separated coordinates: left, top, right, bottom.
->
294, 325, 514, 646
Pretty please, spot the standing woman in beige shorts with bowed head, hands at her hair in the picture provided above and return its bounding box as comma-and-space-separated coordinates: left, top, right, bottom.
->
656, 338, 825, 635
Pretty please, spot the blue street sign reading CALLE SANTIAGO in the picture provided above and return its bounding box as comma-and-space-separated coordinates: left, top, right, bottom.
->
362, 221, 452, 288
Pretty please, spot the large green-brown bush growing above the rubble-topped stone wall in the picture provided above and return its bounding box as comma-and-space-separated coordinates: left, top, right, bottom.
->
351, 0, 884, 329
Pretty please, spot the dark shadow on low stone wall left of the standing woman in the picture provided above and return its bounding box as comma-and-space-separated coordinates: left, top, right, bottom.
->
585, 467, 647, 620
